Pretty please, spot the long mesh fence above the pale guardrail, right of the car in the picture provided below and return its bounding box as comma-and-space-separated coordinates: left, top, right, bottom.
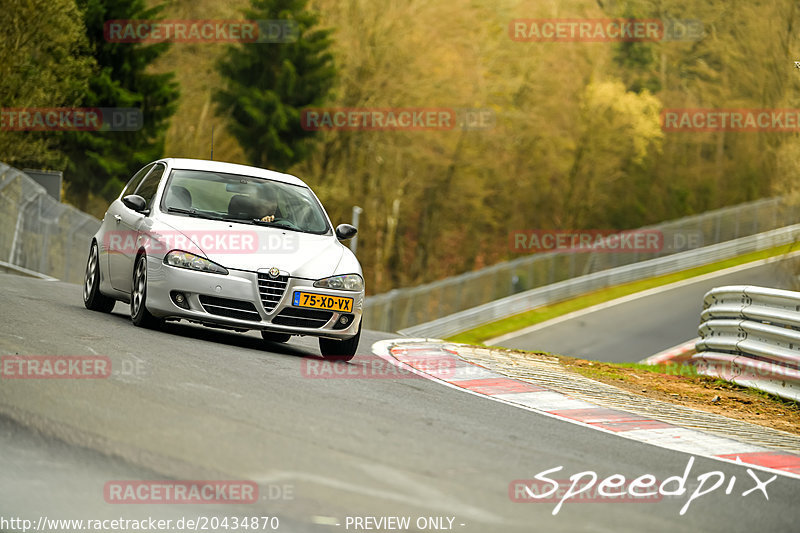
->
364, 198, 800, 331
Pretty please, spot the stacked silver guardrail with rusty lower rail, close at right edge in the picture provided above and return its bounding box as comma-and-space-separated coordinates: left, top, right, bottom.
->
691, 285, 800, 400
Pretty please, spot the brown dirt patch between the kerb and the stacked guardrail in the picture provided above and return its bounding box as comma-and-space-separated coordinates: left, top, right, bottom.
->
559, 357, 800, 435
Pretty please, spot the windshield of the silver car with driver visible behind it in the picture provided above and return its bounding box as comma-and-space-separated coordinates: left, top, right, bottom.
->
161, 169, 329, 234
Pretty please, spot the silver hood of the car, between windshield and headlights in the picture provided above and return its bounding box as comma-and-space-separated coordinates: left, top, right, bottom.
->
159, 215, 345, 279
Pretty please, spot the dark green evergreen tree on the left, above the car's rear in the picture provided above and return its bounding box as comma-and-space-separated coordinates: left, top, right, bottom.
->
62, 0, 178, 208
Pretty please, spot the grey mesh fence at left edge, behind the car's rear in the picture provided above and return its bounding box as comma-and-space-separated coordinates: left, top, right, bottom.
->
0, 163, 100, 283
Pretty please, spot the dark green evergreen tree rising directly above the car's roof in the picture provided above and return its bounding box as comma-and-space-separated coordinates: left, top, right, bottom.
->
214, 0, 336, 170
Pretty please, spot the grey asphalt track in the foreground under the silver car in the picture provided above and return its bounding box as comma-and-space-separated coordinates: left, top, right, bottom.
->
0, 274, 800, 533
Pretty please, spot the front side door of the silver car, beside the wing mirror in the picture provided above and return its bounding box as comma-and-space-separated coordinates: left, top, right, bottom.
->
109, 163, 166, 293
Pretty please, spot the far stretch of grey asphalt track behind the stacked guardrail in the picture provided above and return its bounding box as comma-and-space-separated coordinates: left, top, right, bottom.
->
494, 262, 790, 362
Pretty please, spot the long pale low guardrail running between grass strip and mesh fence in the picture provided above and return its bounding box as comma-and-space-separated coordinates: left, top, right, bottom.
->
400, 224, 800, 338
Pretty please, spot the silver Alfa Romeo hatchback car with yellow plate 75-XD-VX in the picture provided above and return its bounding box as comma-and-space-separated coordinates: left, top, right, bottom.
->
83, 159, 364, 360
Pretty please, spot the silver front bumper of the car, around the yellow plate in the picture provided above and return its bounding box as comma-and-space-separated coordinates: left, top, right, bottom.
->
146, 257, 364, 339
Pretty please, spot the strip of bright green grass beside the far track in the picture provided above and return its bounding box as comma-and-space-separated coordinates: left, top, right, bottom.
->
447, 243, 795, 346
